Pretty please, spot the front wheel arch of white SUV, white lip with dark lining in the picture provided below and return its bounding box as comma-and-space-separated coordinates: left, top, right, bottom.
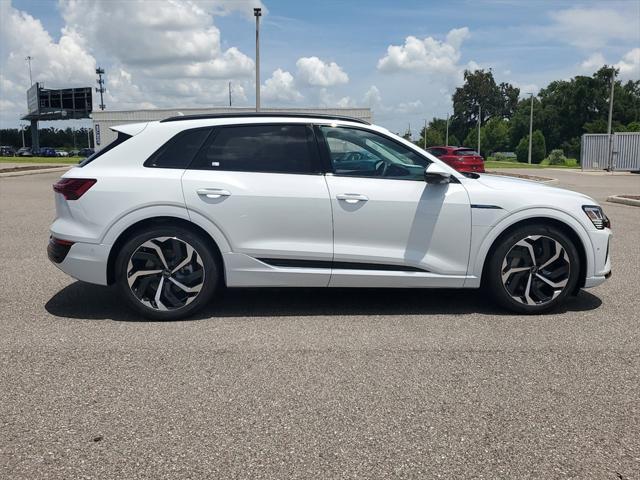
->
475, 212, 594, 293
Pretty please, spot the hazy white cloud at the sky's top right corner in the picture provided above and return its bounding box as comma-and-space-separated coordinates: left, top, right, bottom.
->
544, 7, 638, 49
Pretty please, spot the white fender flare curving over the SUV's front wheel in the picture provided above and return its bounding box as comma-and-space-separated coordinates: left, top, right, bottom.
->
469, 207, 595, 278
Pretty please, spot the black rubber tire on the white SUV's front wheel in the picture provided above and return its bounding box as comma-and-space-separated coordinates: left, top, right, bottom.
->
484, 224, 580, 314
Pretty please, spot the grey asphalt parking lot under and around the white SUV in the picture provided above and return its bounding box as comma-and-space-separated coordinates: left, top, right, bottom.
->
0, 170, 640, 479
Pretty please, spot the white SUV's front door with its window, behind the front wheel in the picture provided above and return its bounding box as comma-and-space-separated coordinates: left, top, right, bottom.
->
318, 125, 471, 287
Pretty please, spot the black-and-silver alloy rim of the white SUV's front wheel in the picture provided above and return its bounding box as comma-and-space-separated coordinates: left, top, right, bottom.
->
500, 235, 571, 305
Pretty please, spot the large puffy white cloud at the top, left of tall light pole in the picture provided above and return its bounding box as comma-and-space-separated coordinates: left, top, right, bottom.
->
60, 0, 253, 78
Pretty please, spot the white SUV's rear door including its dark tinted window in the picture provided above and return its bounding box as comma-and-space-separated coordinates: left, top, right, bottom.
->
182, 123, 333, 286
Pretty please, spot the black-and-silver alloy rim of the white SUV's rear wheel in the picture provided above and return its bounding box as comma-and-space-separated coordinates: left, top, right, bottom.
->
127, 237, 204, 311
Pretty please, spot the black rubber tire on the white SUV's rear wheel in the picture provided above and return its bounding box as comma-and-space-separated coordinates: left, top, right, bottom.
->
115, 225, 220, 321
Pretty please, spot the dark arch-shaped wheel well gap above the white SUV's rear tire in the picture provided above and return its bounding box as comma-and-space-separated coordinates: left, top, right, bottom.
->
107, 216, 226, 285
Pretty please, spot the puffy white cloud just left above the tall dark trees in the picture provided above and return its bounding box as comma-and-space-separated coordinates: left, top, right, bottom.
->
378, 27, 469, 76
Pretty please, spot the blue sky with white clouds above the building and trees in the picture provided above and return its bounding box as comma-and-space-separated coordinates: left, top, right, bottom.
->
0, 0, 640, 136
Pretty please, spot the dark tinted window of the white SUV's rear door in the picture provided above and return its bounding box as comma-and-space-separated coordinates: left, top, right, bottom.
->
191, 124, 320, 174
